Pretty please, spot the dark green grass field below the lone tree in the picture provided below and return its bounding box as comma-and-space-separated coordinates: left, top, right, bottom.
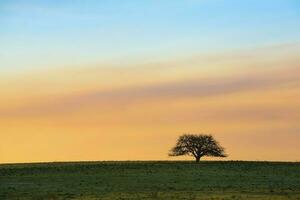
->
0, 161, 300, 200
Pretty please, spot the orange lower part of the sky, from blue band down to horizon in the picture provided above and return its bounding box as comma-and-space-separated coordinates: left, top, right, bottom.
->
0, 44, 300, 163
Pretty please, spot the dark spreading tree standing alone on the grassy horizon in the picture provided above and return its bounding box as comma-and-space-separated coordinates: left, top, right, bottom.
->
169, 134, 227, 162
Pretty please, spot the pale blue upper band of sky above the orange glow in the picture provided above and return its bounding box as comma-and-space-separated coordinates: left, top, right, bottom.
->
0, 0, 300, 70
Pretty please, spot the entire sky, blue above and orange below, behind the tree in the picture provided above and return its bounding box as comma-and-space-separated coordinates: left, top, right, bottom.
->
0, 0, 300, 163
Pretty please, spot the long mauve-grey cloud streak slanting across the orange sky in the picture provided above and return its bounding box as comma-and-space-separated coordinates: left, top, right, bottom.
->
0, 64, 300, 116
